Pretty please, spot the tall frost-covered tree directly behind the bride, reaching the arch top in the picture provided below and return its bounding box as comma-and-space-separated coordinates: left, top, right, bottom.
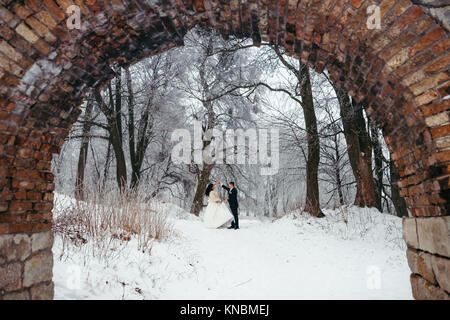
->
182, 28, 260, 215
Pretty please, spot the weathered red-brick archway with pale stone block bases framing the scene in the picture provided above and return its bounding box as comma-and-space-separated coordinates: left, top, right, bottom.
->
0, 0, 450, 299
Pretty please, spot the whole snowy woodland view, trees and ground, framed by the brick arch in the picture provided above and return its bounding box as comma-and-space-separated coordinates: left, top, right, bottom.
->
40, 27, 420, 299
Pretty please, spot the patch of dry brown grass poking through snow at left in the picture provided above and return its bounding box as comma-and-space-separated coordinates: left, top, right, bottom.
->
54, 191, 172, 258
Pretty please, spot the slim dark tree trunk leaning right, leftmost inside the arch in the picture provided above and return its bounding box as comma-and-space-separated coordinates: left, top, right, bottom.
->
75, 97, 93, 200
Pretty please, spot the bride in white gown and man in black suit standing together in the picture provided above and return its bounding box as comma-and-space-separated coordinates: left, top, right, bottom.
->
203, 181, 239, 230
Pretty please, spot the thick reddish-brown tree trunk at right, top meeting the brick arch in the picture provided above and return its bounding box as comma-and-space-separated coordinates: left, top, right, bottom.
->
335, 87, 377, 207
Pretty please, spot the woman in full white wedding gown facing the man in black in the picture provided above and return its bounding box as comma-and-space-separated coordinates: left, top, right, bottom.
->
203, 183, 234, 229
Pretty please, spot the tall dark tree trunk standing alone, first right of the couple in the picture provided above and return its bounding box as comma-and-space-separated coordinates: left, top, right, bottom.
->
299, 63, 324, 217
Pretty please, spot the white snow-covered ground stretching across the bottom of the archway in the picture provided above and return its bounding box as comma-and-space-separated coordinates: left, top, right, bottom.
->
53, 199, 412, 300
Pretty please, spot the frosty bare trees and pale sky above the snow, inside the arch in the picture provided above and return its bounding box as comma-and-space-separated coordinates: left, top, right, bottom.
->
53, 28, 408, 217
